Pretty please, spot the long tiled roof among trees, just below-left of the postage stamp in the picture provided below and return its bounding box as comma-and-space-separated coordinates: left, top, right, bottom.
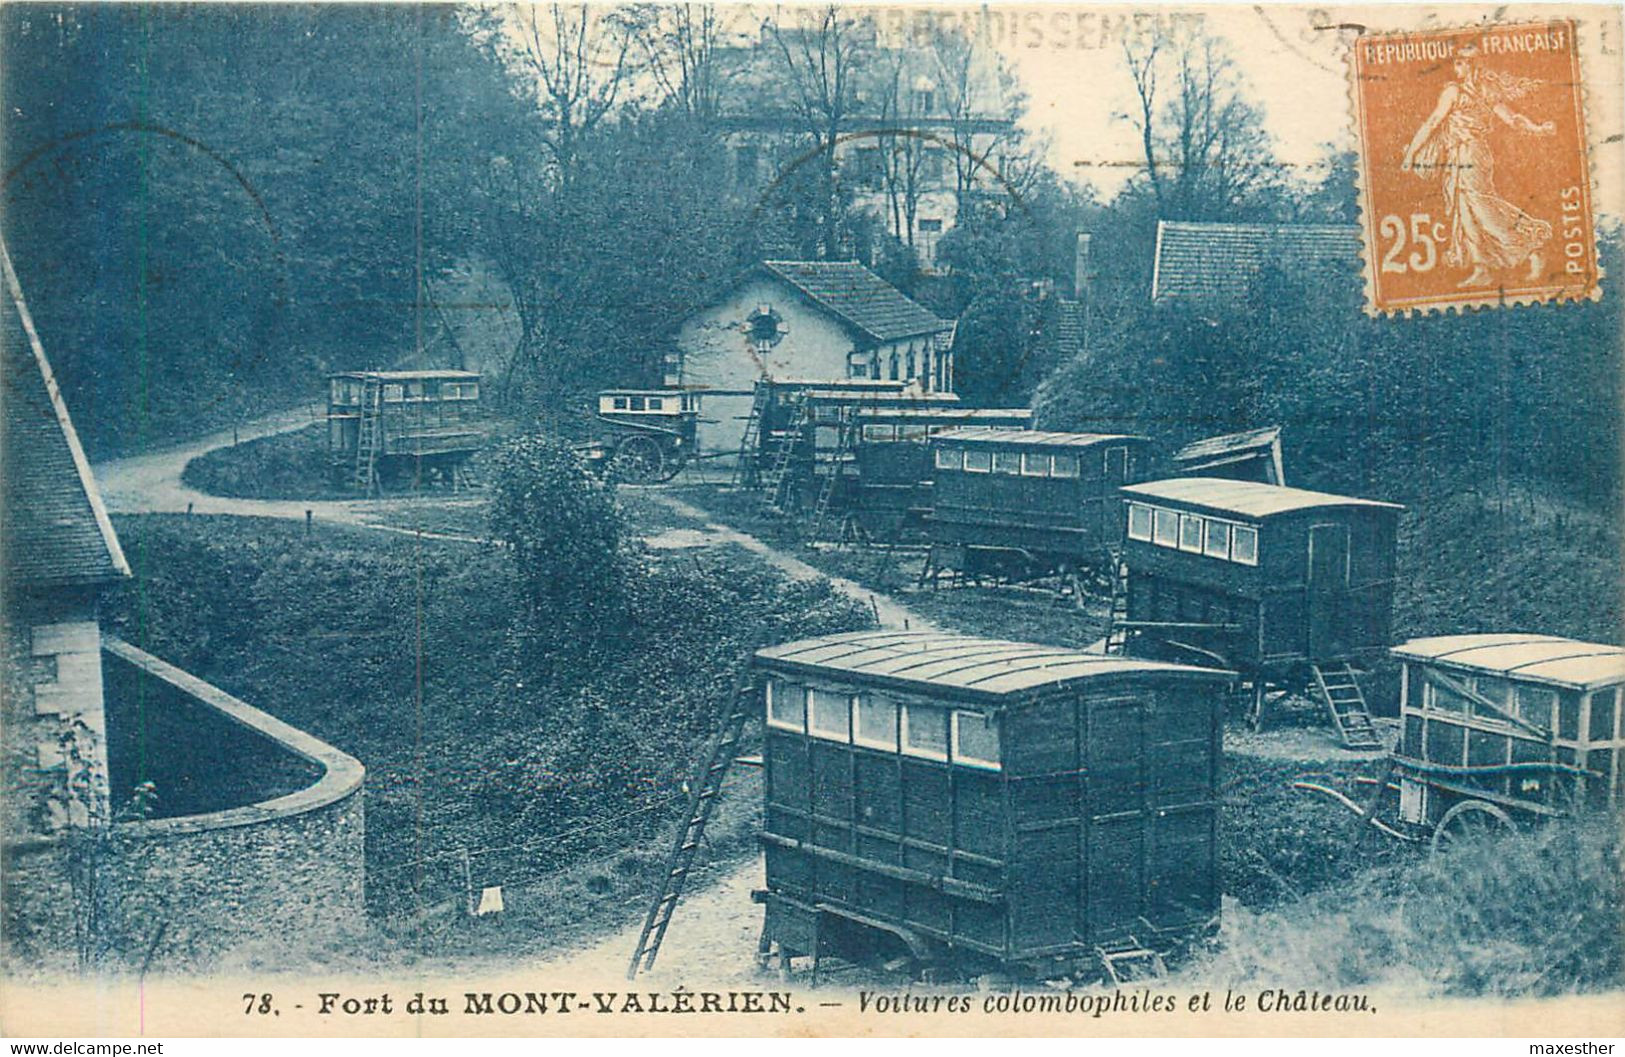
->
1151, 221, 1360, 301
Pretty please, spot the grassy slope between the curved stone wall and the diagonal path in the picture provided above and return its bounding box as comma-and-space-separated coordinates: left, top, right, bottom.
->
111, 517, 869, 909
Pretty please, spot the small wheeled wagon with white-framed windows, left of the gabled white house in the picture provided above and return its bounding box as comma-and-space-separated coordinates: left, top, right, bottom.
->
582, 389, 700, 485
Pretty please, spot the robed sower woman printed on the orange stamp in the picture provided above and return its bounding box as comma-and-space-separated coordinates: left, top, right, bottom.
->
1399, 44, 1557, 286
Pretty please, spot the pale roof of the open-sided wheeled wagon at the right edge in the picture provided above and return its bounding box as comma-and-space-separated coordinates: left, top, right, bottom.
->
1391, 634, 1625, 689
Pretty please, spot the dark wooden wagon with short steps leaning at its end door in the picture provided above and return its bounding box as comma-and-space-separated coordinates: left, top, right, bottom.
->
1107, 478, 1404, 748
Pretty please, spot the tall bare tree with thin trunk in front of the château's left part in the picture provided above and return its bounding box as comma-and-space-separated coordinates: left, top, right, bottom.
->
769, 3, 871, 257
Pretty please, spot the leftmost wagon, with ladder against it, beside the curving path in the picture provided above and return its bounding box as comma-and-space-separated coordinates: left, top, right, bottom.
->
327, 371, 486, 493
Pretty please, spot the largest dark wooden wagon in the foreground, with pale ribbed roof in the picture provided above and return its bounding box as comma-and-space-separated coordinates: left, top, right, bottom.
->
756, 631, 1232, 977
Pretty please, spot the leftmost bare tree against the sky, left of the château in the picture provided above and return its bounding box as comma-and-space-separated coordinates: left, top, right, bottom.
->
512, 3, 634, 185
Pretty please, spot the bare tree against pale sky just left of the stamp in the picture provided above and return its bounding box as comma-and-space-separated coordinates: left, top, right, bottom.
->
1123, 24, 1277, 220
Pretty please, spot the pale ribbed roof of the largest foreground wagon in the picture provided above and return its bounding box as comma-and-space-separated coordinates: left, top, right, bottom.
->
756, 631, 1232, 698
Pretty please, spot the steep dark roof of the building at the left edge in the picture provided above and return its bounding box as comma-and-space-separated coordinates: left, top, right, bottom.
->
0, 246, 130, 587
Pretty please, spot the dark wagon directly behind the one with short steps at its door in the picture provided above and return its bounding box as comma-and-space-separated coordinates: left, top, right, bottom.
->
920, 428, 1151, 598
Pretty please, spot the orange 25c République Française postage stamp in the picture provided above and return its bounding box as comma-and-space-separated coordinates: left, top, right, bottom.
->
1350, 20, 1599, 314
